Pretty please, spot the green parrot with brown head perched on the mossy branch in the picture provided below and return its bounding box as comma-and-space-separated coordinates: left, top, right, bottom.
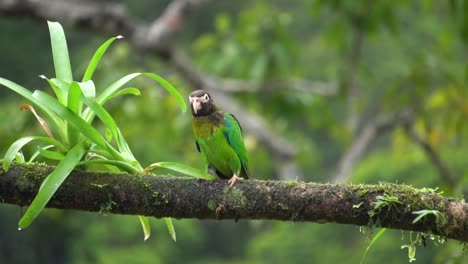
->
189, 90, 248, 186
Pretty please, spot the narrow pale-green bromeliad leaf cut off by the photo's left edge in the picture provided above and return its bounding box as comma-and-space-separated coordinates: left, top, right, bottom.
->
0, 77, 66, 140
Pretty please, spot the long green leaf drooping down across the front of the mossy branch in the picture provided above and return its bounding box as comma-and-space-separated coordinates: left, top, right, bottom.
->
18, 142, 86, 228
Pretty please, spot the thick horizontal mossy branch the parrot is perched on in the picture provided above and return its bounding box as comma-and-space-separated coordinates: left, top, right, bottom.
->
0, 164, 468, 242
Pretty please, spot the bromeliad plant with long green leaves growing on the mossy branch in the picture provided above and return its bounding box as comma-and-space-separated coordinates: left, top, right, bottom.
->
0, 22, 209, 240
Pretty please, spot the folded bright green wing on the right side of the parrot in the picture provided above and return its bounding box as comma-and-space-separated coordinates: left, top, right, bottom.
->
224, 113, 249, 179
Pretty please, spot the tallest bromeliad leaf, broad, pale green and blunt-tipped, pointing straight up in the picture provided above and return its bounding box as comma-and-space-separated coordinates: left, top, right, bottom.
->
47, 21, 73, 83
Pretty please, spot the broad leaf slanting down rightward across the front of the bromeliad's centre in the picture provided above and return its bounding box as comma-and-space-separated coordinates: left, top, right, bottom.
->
33, 91, 107, 148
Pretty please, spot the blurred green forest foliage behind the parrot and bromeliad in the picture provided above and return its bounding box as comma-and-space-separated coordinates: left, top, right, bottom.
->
0, 0, 468, 264
